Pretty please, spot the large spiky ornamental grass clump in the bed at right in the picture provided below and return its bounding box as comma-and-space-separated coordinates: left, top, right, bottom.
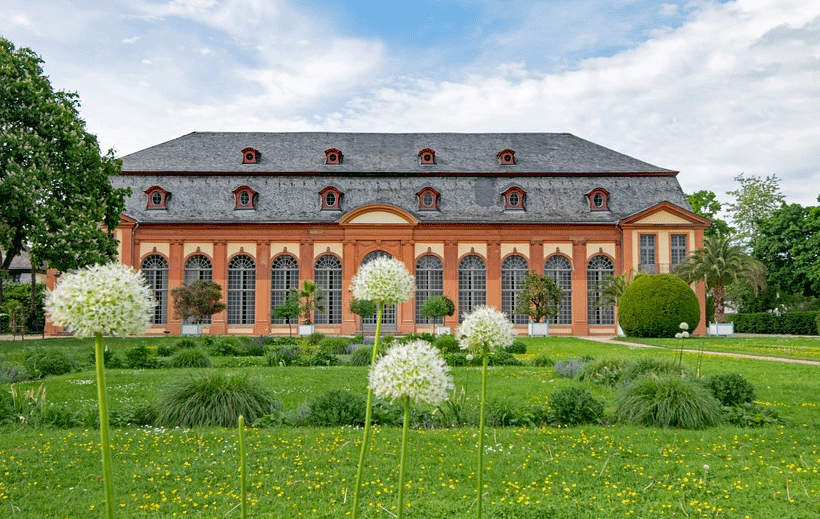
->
616, 376, 722, 429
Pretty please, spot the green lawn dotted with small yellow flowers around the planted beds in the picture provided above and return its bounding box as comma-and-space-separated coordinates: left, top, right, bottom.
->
0, 338, 820, 519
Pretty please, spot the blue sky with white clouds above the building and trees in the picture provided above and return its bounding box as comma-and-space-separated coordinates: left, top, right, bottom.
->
0, 0, 820, 211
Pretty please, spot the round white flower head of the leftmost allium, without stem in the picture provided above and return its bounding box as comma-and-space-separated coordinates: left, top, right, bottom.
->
46, 263, 156, 337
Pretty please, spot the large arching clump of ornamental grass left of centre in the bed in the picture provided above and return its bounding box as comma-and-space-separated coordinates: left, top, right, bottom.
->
156, 371, 280, 427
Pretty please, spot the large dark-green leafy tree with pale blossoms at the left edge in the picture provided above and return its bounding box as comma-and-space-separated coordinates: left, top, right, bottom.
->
0, 38, 129, 301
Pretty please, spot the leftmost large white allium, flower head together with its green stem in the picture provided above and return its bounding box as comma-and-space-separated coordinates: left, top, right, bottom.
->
46, 263, 156, 518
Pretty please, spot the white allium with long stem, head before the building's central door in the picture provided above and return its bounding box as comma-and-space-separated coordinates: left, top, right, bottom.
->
353, 256, 413, 519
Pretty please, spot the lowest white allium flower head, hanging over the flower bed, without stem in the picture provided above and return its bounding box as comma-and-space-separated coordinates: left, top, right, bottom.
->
368, 340, 453, 405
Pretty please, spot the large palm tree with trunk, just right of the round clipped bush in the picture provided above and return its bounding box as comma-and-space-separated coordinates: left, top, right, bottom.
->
675, 234, 768, 323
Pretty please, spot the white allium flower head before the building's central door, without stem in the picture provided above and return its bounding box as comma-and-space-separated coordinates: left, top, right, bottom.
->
353, 256, 413, 304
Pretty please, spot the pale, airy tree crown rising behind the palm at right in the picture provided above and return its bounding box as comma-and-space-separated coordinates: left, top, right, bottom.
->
726, 173, 785, 249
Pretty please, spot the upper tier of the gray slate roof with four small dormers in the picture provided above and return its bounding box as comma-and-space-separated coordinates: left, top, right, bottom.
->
122, 132, 676, 175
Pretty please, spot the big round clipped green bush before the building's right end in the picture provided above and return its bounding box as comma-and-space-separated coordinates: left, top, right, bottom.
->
618, 274, 700, 337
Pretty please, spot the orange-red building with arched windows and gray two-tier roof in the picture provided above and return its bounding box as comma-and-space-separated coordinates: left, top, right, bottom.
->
48, 132, 709, 335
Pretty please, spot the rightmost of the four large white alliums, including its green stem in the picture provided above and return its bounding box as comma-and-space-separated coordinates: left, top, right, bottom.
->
458, 306, 515, 519
